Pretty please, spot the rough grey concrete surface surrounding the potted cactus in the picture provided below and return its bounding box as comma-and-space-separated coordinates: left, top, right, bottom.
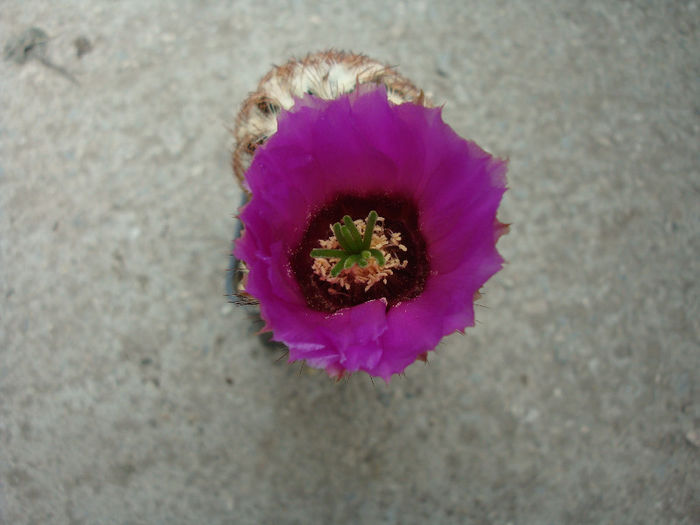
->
0, 1, 700, 524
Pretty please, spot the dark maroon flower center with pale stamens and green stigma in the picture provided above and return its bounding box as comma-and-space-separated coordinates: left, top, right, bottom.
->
290, 195, 429, 313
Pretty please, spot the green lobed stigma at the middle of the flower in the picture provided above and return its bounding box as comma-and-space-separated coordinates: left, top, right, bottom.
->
311, 210, 385, 277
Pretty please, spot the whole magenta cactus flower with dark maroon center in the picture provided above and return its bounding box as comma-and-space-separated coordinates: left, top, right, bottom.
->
234, 85, 507, 381
